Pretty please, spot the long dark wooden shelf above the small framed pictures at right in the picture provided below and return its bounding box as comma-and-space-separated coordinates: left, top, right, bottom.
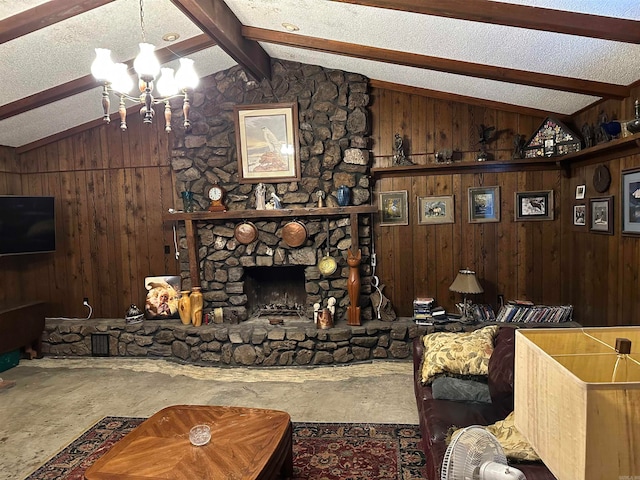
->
371, 133, 640, 178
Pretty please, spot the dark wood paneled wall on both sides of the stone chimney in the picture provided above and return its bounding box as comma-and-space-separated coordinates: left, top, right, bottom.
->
0, 82, 640, 325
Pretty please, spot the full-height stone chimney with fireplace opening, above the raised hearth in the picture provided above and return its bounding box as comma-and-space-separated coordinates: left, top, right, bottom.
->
171, 60, 372, 323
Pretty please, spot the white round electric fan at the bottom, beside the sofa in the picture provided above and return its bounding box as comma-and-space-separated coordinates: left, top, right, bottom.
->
440, 425, 526, 480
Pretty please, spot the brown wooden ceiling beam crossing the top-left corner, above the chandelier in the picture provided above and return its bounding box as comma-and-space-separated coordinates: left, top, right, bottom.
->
0, 0, 114, 45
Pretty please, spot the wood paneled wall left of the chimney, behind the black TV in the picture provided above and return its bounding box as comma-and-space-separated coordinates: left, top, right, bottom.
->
0, 121, 179, 318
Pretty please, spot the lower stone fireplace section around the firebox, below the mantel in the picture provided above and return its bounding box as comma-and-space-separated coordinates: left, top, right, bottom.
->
181, 216, 372, 323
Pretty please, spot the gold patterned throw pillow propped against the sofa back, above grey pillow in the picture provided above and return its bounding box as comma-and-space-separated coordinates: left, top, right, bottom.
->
421, 325, 500, 384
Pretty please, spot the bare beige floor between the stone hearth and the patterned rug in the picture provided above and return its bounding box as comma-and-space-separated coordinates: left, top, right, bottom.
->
0, 358, 418, 480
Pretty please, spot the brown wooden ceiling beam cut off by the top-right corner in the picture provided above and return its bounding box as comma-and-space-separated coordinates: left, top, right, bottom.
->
333, 0, 640, 44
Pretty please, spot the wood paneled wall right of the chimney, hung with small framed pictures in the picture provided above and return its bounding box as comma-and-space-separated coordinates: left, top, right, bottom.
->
372, 89, 640, 325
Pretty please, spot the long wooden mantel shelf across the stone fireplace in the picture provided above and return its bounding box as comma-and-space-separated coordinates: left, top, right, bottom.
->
162, 205, 377, 222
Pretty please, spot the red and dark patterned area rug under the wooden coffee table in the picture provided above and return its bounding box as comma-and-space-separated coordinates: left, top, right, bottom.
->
27, 417, 425, 480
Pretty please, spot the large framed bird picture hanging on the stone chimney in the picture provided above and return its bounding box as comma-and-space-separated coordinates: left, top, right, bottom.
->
234, 102, 300, 183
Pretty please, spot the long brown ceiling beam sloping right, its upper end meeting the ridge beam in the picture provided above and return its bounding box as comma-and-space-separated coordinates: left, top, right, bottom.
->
242, 27, 631, 99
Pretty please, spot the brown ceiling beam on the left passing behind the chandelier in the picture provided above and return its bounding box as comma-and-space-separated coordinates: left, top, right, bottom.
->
0, 34, 216, 120
